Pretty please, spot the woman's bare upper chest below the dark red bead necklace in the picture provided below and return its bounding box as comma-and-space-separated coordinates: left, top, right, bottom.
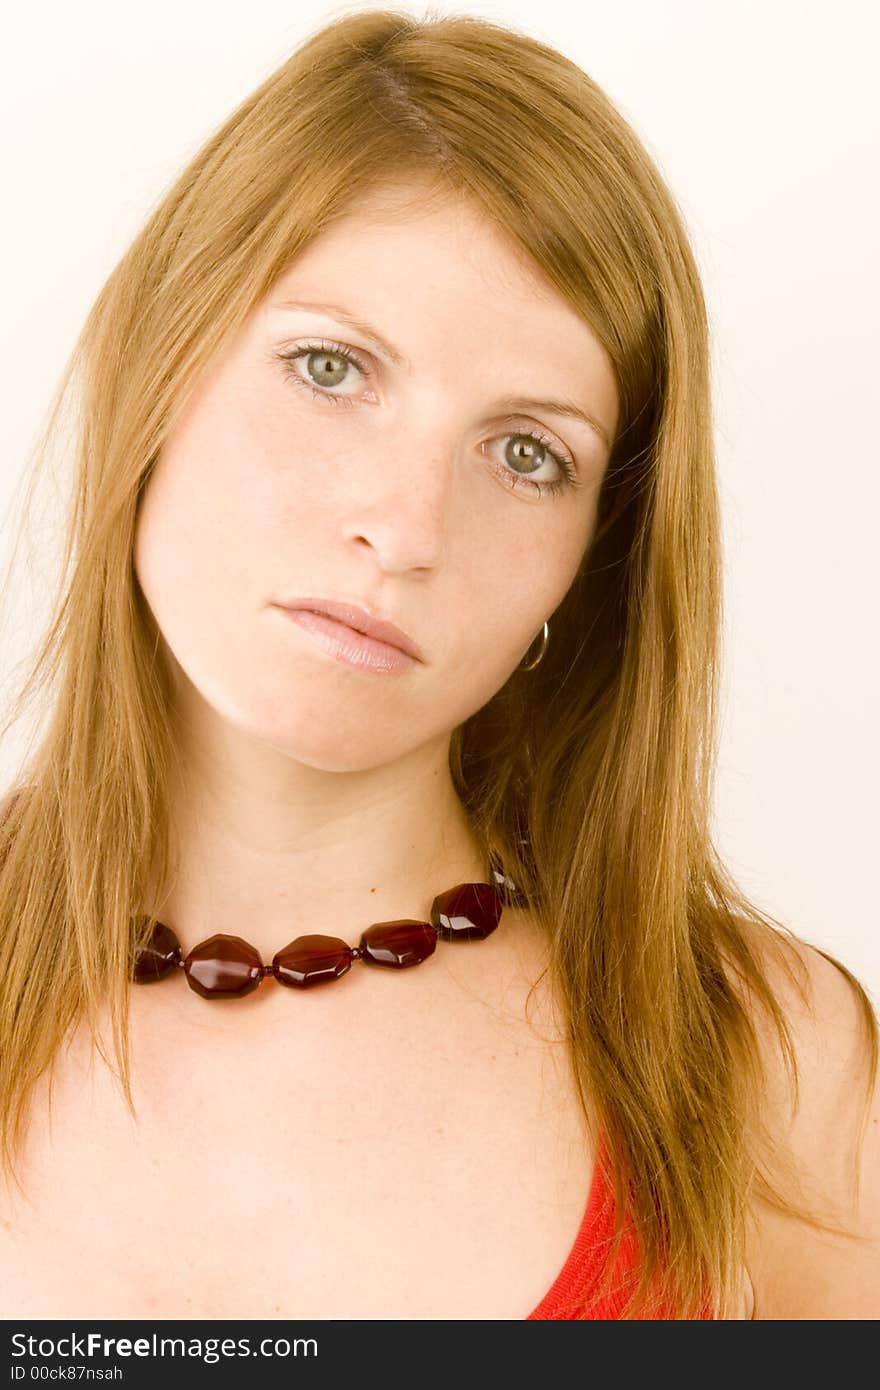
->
0, 945, 592, 1319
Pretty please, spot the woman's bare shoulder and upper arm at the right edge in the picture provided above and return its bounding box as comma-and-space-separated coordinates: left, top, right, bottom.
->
728, 923, 880, 1319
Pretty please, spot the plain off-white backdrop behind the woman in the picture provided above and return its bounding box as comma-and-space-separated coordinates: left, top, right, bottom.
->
0, 0, 880, 1005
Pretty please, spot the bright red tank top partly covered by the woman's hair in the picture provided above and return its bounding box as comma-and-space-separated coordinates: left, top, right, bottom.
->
525, 1136, 713, 1322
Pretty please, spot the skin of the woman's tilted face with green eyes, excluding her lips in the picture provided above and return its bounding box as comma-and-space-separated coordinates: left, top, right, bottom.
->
135, 185, 617, 771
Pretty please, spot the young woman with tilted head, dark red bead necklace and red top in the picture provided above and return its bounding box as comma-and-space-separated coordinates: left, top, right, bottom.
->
0, 11, 880, 1319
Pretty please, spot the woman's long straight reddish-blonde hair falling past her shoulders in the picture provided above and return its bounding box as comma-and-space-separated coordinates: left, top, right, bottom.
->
0, 10, 877, 1318
